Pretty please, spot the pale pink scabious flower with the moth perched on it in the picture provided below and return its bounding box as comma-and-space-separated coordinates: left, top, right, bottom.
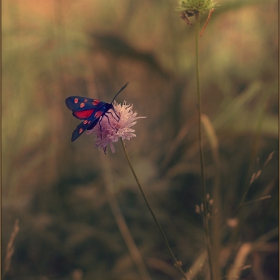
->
86, 101, 145, 153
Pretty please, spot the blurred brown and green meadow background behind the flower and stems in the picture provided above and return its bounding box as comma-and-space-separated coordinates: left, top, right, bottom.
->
2, 0, 279, 280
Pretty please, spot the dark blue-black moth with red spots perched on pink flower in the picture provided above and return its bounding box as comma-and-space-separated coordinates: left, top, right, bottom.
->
65, 83, 128, 142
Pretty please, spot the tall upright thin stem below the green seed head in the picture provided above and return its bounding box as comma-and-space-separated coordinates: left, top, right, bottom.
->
195, 12, 214, 280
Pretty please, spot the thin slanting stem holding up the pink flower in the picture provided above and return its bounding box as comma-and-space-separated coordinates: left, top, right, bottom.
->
121, 139, 188, 279
